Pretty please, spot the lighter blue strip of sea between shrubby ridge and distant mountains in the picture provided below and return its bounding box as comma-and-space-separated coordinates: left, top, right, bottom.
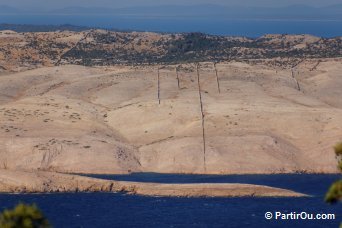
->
0, 15, 342, 37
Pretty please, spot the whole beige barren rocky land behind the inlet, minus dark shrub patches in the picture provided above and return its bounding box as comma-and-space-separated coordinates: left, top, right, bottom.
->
0, 31, 342, 174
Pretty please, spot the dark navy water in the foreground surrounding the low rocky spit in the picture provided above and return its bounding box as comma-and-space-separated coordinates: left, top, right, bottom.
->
0, 174, 342, 227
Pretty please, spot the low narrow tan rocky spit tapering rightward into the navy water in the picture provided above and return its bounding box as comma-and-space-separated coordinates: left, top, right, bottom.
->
0, 170, 307, 197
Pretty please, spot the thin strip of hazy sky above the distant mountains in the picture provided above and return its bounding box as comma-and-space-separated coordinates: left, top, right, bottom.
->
0, 0, 342, 9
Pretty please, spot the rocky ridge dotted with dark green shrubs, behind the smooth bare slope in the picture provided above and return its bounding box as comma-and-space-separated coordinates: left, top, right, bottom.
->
0, 30, 342, 70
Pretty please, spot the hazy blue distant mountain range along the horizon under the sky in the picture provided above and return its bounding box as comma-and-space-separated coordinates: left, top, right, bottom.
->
0, 4, 342, 20
